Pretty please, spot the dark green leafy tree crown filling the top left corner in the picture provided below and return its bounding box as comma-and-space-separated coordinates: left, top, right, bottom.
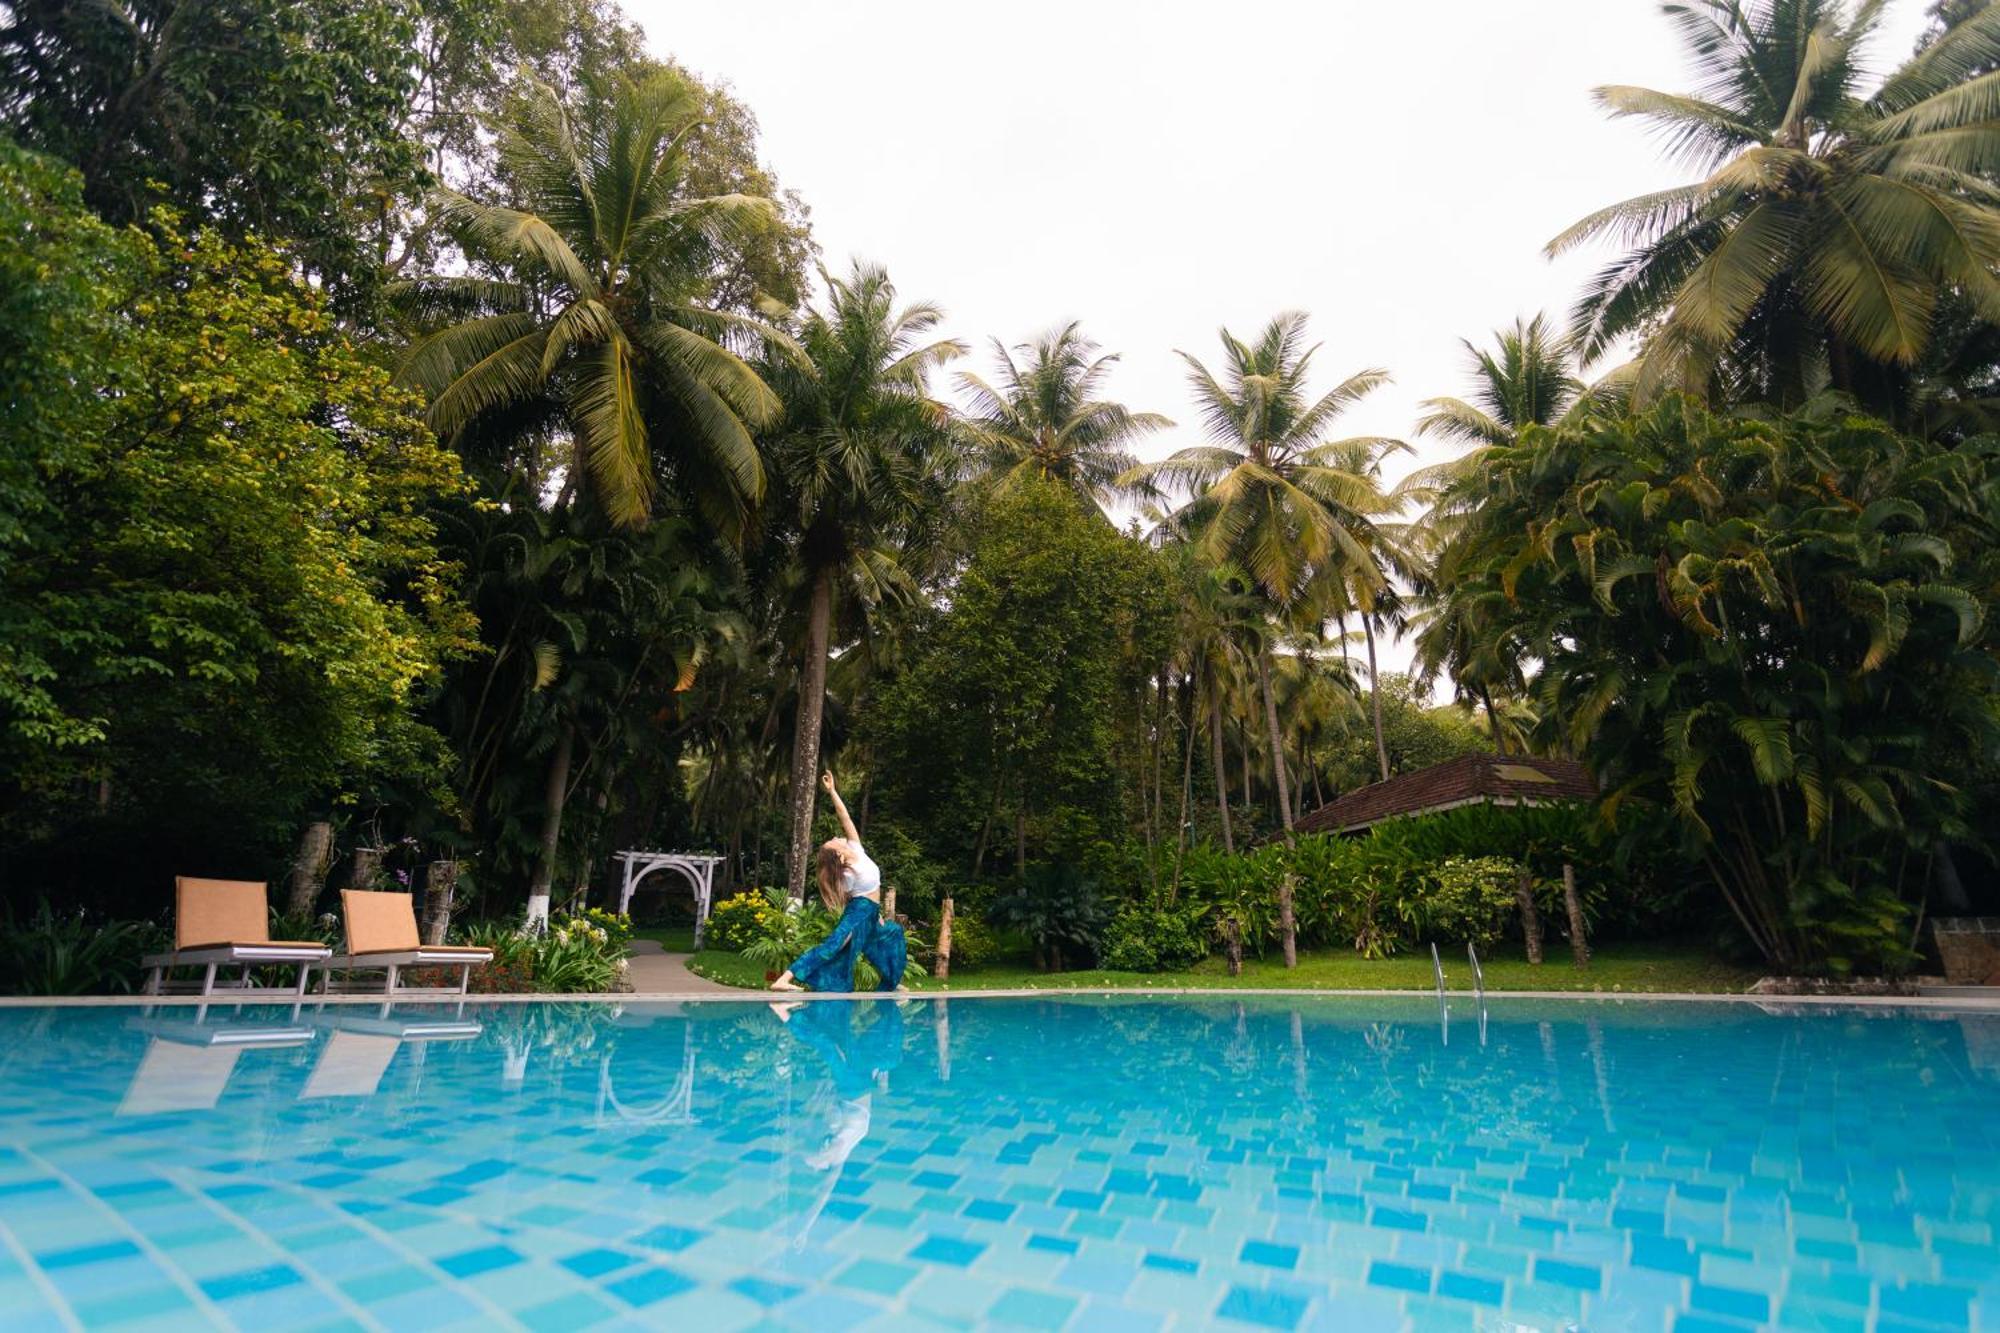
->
0, 0, 424, 294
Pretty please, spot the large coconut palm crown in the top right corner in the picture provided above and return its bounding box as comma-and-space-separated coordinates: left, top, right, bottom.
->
1548, 0, 2000, 402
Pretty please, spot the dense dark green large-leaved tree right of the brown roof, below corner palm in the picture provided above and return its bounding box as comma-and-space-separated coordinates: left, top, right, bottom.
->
1454, 396, 2000, 969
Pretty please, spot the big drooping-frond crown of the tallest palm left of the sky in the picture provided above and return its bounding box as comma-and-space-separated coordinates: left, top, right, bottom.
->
396, 72, 780, 528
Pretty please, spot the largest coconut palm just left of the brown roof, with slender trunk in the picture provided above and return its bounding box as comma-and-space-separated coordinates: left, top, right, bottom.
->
1128, 312, 1396, 835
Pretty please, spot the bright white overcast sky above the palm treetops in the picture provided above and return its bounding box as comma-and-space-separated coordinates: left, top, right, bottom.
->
624, 0, 1928, 658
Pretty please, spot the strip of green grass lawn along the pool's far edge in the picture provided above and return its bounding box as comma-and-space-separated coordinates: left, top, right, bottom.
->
688, 945, 1760, 995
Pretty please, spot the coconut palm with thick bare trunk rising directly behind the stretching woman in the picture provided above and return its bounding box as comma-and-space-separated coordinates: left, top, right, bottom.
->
768, 262, 966, 897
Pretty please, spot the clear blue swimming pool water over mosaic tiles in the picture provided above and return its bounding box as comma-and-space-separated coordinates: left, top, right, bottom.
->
0, 997, 2000, 1333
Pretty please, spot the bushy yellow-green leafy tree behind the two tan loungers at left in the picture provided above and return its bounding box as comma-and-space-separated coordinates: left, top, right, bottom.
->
0, 148, 470, 888
